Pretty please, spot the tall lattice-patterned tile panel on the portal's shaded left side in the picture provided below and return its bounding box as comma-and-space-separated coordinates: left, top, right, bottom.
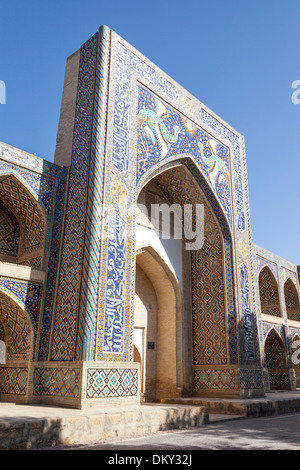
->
51, 34, 97, 360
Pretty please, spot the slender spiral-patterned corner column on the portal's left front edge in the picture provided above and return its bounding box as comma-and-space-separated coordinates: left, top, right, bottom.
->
76, 27, 110, 360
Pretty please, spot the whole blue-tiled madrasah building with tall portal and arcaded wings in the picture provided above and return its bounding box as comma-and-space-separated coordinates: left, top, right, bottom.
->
0, 26, 300, 408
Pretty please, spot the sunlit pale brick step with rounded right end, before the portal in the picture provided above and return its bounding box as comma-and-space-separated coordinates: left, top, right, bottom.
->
0, 404, 209, 450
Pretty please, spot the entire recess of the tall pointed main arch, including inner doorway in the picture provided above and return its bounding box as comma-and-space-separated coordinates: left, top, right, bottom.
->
135, 161, 245, 399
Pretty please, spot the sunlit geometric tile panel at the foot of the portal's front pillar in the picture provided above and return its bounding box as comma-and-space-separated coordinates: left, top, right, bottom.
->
86, 368, 138, 398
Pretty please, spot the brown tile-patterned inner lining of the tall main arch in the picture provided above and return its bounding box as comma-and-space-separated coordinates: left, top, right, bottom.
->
137, 159, 238, 396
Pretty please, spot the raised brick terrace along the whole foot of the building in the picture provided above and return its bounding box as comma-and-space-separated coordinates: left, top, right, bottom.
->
0, 391, 300, 450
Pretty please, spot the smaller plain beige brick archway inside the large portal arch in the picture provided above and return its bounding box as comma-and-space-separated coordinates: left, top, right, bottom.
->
134, 246, 182, 401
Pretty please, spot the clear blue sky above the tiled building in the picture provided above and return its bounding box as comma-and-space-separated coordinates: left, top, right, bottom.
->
0, 0, 300, 264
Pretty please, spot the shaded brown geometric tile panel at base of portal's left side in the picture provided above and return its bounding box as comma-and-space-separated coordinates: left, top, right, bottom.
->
33, 367, 80, 398
